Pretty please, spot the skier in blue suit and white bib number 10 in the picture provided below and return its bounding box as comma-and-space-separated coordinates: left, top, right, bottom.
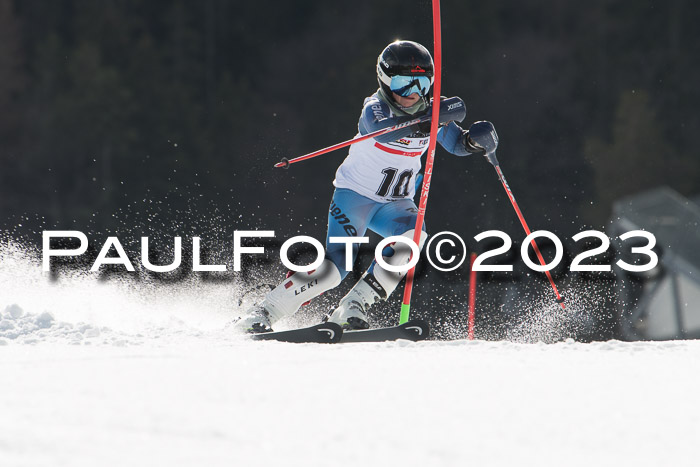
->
236, 41, 498, 333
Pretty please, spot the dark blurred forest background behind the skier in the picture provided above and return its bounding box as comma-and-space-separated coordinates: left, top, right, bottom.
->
0, 0, 700, 247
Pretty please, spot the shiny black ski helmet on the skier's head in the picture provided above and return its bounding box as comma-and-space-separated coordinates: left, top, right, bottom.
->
377, 41, 435, 97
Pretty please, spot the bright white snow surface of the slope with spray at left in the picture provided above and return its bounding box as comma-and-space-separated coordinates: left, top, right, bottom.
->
0, 239, 700, 467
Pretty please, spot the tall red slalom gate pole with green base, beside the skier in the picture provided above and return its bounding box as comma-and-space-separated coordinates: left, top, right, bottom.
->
399, 0, 442, 324
